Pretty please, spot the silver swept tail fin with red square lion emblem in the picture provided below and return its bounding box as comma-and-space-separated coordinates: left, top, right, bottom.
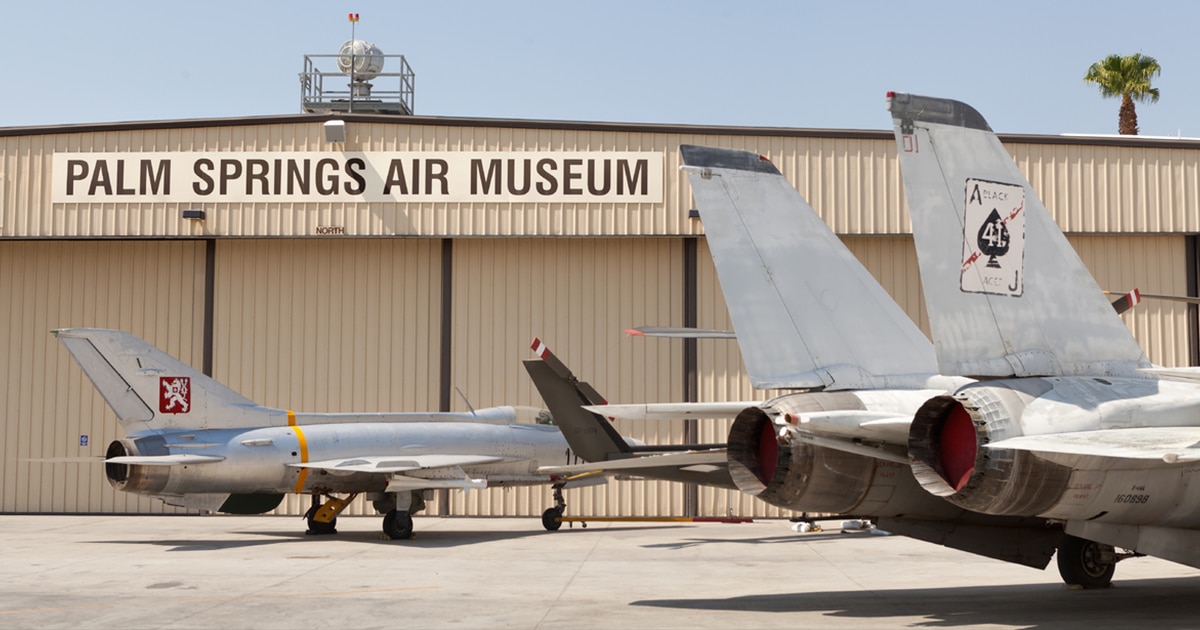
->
53, 329, 267, 433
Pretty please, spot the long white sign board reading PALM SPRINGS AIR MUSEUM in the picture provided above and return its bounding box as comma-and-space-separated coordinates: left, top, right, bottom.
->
50, 151, 664, 203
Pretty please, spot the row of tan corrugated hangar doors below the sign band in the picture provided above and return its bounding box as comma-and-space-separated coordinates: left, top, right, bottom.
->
0, 235, 1188, 516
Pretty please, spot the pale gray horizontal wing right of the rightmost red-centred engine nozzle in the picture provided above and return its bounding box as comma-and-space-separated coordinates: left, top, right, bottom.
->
988, 426, 1200, 466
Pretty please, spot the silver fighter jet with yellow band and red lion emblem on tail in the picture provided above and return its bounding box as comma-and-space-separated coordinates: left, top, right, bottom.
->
54, 329, 605, 539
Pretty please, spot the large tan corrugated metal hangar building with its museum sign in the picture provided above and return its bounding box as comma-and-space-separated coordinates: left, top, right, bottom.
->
0, 63, 1200, 516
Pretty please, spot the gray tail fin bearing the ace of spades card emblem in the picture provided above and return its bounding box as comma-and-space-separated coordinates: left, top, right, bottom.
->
888, 94, 1150, 377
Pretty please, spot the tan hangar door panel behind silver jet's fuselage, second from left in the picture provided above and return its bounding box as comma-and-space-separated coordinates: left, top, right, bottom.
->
212, 239, 442, 514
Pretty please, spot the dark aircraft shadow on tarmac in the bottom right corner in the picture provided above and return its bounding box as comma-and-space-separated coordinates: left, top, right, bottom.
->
630, 568, 1200, 630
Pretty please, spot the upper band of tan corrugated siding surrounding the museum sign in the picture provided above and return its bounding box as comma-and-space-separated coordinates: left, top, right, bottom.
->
9, 120, 1200, 238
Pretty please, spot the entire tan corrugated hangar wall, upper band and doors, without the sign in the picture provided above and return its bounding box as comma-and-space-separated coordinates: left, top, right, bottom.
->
0, 116, 1200, 516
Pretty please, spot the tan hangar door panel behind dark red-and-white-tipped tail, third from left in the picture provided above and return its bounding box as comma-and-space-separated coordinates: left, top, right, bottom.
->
450, 239, 683, 516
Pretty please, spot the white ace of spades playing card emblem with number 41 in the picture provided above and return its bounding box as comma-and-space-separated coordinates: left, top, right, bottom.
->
959, 178, 1025, 296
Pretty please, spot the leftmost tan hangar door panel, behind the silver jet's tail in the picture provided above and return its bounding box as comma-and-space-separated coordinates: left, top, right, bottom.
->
0, 241, 204, 514
